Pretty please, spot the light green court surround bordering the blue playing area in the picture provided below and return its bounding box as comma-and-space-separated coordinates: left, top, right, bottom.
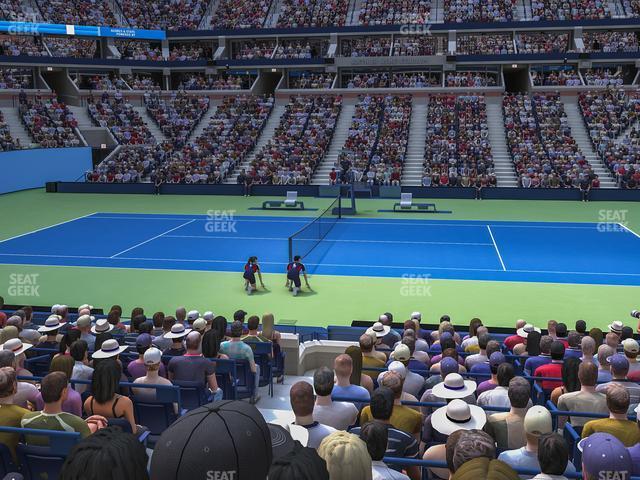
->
0, 190, 640, 328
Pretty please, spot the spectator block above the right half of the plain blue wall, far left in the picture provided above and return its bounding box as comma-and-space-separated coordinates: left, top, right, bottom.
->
18, 93, 80, 148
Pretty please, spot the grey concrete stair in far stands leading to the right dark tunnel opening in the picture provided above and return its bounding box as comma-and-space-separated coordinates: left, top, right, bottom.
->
485, 97, 518, 187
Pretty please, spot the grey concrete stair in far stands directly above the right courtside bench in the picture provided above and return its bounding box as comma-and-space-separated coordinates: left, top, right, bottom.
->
401, 97, 428, 187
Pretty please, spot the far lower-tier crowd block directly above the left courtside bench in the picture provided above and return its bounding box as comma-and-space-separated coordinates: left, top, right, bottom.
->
246, 95, 342, 185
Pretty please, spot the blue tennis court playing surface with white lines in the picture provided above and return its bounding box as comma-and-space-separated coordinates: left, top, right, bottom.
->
0, 213, 640, 286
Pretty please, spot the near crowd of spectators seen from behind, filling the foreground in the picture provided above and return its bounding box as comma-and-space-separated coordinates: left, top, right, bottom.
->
0, 297, 640, 480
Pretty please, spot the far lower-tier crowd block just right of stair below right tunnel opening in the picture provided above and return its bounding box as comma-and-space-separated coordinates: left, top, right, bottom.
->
503, 93, 600, 189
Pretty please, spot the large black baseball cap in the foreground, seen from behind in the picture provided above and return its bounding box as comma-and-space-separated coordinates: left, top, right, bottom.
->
151, 400, 273, 480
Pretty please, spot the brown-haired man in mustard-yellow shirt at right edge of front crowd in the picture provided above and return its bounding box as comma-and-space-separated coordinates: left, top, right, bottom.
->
582, 383, 640, 447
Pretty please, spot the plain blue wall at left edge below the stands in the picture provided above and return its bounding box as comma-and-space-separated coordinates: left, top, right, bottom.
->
0, 147, 92, 193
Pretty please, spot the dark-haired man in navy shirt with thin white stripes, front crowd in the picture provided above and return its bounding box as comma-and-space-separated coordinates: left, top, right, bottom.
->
350, 387, 420, 479
